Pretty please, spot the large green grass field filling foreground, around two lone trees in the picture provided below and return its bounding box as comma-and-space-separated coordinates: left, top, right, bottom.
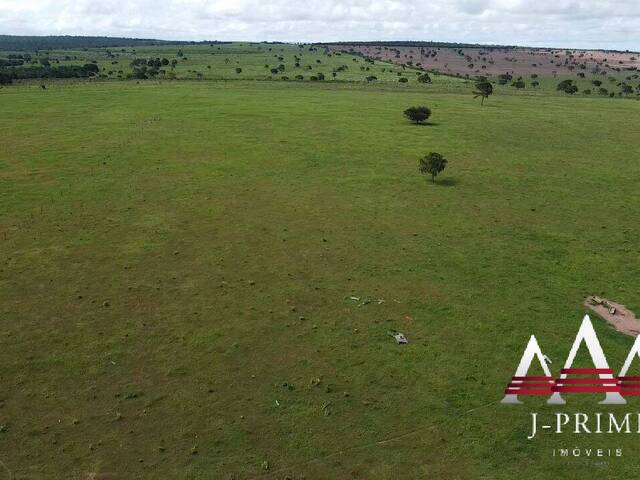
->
0, 49, 640, 480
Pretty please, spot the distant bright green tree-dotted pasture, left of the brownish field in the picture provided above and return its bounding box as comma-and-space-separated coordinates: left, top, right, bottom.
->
0, 43, 432, 83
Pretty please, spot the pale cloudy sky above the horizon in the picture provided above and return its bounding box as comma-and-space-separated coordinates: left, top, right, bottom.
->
0, 0, 640, 50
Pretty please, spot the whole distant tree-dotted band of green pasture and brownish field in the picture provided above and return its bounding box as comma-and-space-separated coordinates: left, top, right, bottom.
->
5, 43, 640, 99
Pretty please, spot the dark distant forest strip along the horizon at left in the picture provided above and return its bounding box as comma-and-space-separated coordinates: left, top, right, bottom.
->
0, 35, 228, 51
